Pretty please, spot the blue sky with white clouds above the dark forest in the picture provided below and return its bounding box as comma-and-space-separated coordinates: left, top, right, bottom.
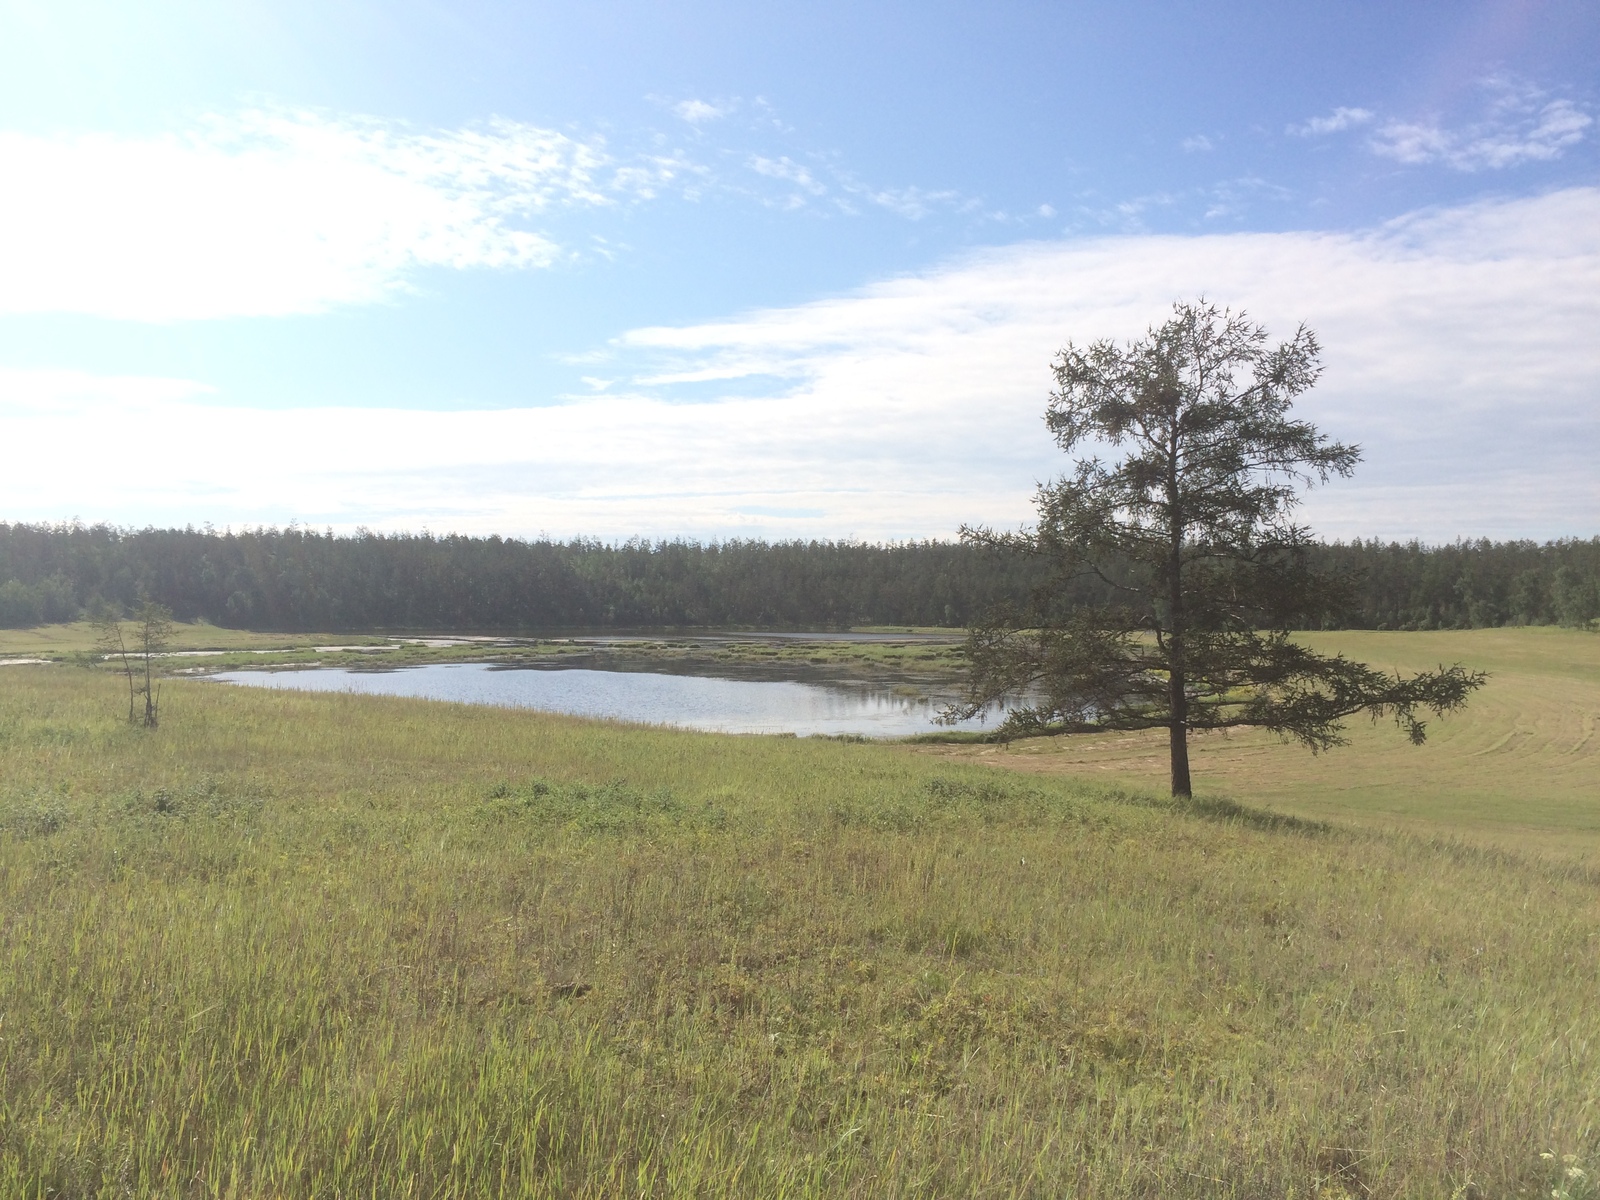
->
0, 0, 1600, 542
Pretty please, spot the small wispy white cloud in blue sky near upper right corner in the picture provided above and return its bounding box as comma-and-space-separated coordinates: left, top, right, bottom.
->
1370, 77, 1594, 171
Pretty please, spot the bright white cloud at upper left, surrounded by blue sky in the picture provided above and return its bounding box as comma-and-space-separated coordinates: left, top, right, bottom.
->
0, 112, 643, 320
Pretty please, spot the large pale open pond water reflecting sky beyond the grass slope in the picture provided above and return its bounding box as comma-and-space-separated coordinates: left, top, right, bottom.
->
211, 662, 995, 738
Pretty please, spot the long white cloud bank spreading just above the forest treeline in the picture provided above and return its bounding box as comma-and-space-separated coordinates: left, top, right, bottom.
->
0, 189, 1600, 539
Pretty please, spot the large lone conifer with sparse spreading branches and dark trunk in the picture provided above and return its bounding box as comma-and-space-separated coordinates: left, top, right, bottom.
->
946, 299, 1485, 797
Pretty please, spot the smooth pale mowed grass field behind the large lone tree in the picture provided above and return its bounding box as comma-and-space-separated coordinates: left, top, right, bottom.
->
917, 627, 1600, 858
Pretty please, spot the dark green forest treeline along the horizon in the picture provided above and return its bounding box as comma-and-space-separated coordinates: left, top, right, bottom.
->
0, 523, 1600, 632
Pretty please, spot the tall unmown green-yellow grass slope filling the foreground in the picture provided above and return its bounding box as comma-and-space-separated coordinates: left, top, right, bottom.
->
0, 667, 1600, 1197
